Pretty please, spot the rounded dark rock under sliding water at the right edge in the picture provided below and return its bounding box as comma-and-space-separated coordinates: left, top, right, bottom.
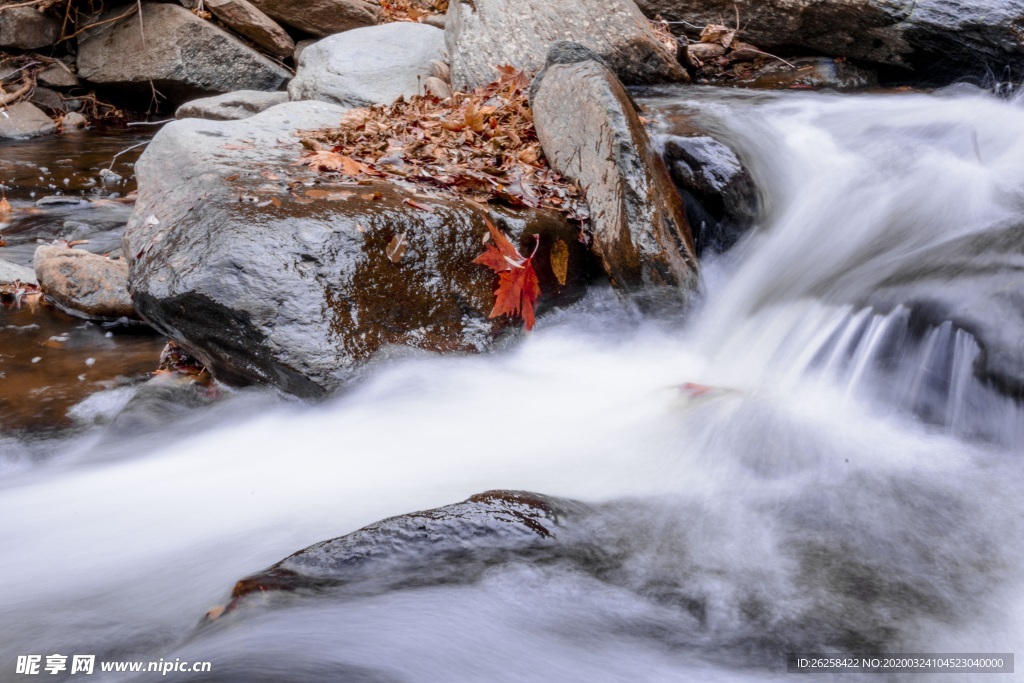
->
863, 224, 1024, 397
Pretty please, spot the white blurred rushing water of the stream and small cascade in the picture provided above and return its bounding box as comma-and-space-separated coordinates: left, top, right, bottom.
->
6, 88, 1024, 682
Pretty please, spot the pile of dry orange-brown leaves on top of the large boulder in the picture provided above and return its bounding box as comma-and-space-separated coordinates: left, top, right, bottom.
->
299, 67, 587, 221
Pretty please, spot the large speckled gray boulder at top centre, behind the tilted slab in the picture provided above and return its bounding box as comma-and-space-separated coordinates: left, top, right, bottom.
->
445, 0, 687, 90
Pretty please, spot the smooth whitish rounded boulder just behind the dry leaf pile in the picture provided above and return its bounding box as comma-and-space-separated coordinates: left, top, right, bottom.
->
288, 23, 444, 106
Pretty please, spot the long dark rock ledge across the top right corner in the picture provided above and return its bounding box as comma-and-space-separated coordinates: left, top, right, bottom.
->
637, 0, 1024, 78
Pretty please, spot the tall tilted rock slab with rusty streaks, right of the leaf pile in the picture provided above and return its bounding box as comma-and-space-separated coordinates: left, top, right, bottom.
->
530, 42, 698, 293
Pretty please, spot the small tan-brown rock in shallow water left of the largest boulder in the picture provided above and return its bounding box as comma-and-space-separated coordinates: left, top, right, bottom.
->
34, 245, 138, 319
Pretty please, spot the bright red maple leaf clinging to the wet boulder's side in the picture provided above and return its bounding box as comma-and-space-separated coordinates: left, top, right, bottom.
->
473, 218, 541, 330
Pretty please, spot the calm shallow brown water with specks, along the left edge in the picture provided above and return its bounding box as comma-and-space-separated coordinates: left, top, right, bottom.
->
0, 129, 165, 434
